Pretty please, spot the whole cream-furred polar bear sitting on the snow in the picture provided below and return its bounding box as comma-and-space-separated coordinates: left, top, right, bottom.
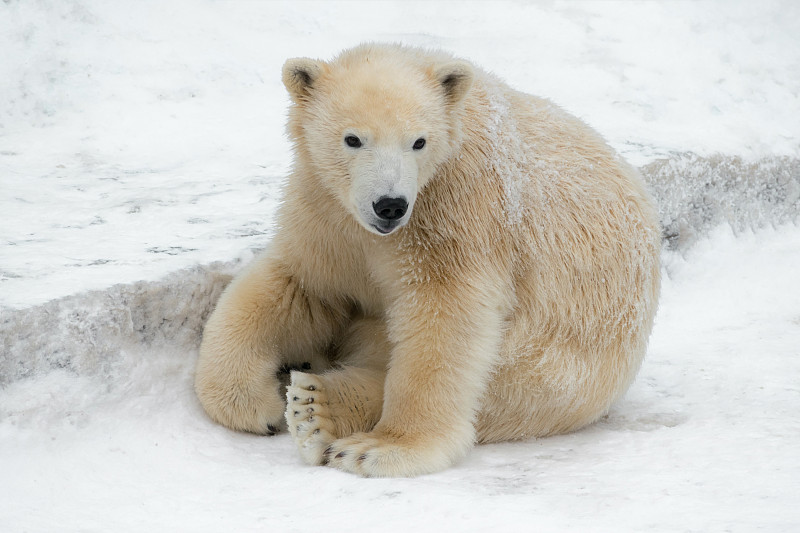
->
196, 44, 660, 476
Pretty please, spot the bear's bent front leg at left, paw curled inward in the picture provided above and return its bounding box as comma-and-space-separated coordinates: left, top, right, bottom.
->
195, 252, 349, 435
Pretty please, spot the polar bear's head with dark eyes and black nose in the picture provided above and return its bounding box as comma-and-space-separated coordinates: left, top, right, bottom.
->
283, 45, 474, 235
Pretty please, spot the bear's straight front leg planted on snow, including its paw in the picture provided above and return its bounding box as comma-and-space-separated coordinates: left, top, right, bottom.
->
328, 276, 504, 477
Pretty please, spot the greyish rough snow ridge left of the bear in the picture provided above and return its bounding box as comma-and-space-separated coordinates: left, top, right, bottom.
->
0, 263, 234, 384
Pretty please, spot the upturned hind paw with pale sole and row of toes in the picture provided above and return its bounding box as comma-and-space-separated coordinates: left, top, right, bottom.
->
286, 371, 336, 465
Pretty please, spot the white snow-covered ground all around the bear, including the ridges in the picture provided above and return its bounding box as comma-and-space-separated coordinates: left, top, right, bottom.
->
0, 0, 800, 531
